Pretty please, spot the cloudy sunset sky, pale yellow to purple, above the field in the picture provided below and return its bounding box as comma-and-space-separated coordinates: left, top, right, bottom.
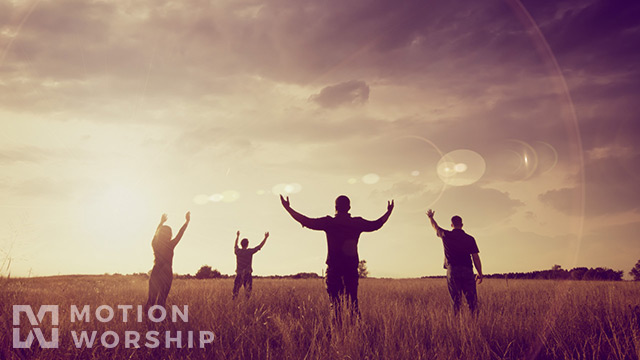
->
0, 0, 640, 277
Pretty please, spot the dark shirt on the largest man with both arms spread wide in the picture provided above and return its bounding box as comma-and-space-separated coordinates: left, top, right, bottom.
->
301, 214, 384, 270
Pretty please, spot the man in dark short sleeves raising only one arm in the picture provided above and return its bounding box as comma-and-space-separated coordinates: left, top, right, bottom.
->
427, 209, 482, 314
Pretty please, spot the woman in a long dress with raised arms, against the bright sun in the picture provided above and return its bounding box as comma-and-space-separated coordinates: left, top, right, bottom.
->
145, 212, 191, 311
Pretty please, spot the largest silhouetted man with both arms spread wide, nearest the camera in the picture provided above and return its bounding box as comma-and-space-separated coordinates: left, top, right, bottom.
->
280, 195, 393, 320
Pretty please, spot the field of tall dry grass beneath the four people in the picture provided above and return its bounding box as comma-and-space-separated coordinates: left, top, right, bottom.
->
0, 276, 640, 359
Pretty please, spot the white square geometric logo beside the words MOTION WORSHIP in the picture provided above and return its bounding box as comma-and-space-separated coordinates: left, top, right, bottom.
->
13, 305, 58, 349
